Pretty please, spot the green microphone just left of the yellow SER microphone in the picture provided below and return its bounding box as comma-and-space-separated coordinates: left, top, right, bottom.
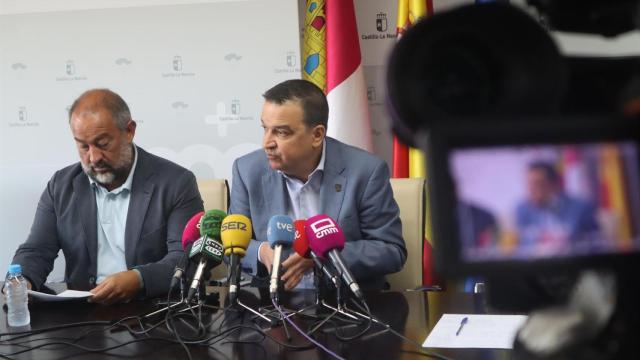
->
187, 210, 227, 303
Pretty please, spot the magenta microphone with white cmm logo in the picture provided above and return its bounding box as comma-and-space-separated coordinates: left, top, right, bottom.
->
305, 214, 364, 301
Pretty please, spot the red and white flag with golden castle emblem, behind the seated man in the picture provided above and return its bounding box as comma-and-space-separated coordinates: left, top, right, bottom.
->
302, 0, 373, 151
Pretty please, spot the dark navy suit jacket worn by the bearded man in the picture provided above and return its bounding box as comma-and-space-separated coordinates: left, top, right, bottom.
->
13, 148, 203, 296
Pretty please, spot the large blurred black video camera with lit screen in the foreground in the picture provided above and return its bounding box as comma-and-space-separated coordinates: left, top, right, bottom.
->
387, 0, 640, 358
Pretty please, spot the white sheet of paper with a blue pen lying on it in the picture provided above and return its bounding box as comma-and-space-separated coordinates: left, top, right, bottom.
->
422, 314, 527, 349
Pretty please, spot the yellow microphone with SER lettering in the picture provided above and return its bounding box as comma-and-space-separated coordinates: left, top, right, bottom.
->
220, 214, 253, 303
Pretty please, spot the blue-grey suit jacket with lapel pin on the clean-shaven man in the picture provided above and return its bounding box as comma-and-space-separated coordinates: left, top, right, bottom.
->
229, 137, 407, 288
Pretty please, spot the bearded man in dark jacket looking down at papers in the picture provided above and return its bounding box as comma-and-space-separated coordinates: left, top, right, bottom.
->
13, 89, 203, 304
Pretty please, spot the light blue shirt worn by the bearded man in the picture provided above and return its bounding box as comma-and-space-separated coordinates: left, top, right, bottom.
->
89, 146, 142, 284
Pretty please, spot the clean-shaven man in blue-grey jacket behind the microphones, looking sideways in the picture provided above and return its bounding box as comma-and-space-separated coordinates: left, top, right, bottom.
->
229, 80, 407, 289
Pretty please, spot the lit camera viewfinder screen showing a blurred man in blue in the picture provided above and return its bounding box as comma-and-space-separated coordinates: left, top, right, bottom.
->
449, 142, 640, 262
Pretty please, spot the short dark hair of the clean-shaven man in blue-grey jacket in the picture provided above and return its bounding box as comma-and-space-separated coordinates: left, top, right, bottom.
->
262, 79, 329, 129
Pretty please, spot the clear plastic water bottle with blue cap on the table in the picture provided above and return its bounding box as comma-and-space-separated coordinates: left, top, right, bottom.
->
4, 264, 31, 326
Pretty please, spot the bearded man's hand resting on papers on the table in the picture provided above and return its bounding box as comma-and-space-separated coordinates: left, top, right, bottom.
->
89, 270, 141, 305
